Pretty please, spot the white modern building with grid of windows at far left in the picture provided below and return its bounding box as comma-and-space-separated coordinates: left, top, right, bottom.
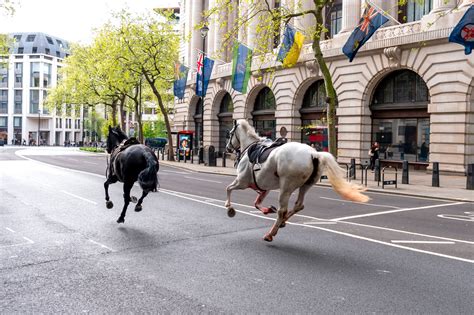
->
0, 33, 83, 145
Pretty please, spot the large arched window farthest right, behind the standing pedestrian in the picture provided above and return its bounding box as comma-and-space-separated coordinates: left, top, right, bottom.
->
370, 70, 430, 162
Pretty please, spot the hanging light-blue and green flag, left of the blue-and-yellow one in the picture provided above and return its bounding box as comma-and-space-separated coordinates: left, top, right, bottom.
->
232, 43, 252, 94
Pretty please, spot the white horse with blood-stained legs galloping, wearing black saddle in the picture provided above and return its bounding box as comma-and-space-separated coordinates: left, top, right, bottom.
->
225, 119, 369, 242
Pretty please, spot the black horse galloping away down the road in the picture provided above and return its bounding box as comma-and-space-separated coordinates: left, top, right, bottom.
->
104, 126, 159, 223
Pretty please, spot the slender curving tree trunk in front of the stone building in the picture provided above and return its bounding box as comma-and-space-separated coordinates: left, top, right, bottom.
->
313, 0, 338, 157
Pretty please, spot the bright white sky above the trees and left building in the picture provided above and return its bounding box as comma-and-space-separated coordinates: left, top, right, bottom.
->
0, 0, 179, 44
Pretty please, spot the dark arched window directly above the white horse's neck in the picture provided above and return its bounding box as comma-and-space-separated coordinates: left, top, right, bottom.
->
252, 87, 276, 139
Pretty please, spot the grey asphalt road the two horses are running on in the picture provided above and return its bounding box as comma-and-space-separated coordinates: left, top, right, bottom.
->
0, 149, 474, 314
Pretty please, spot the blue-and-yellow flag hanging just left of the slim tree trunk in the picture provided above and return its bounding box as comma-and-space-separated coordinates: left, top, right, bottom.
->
277, 25, 304, 67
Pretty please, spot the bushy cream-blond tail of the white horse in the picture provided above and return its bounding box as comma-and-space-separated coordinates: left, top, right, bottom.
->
312, 151, 370, 202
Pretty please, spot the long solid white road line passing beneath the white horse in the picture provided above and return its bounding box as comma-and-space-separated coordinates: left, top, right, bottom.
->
157, 191, 474, 264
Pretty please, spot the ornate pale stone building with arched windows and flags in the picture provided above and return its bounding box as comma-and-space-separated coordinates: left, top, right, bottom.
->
175, 0, 474, 172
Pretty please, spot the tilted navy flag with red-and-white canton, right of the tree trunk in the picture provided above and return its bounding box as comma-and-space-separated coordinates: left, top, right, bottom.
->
342, 4, 388, 62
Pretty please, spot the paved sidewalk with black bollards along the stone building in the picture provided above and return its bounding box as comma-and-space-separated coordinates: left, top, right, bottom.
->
160, 156, 474, 202
